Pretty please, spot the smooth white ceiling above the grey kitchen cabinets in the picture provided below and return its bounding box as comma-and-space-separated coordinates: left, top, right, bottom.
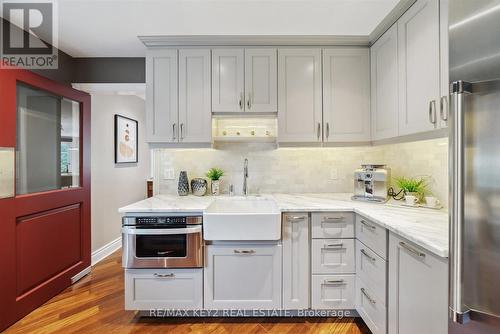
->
58, 0, 399, 57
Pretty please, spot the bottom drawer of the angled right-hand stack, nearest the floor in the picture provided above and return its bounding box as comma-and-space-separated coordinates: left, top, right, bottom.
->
356, 278, 387, 334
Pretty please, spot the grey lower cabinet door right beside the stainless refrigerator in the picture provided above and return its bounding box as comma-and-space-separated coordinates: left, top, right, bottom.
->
389, 233, 448, 334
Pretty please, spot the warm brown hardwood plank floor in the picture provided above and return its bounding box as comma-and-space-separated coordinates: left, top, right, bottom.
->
5, 251, 370, 334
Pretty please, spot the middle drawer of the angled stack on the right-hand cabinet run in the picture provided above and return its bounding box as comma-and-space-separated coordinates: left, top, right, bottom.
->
356, 240, 387, 305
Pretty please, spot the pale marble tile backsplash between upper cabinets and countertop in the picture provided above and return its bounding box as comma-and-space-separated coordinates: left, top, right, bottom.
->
154, 138, 448, 205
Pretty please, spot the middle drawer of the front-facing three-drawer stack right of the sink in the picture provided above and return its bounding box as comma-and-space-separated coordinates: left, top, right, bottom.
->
311, 239, 356, 274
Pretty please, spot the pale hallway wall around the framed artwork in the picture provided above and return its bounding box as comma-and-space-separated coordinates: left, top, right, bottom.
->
91, 93, 149, 251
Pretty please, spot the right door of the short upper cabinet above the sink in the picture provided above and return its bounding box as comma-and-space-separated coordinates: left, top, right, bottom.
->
245, 49, 278, 112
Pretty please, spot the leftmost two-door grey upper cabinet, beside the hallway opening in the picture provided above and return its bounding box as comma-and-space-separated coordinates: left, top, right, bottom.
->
146, 49, 212, 144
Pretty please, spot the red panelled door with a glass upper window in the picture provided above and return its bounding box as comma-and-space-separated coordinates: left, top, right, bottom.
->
0, 69, 90, 331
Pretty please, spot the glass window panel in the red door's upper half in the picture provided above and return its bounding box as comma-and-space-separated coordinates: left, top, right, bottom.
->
16, 84, 80, 195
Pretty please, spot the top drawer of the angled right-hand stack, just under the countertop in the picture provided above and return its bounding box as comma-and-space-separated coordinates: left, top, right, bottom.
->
356, 215, 387, 260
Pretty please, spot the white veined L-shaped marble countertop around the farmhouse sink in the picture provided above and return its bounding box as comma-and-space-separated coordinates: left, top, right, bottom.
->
118, 193, 448, 257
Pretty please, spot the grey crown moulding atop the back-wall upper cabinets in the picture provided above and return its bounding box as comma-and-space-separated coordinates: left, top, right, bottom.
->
138, 35, 369, 48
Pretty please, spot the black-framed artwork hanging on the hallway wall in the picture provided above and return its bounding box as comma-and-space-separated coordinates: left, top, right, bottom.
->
115, 114, 139, 164
